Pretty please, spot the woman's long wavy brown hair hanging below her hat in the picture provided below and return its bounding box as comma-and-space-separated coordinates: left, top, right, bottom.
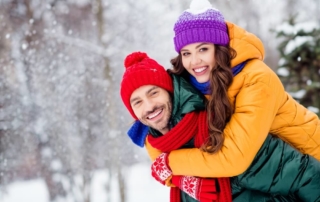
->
168, 45, 236, 153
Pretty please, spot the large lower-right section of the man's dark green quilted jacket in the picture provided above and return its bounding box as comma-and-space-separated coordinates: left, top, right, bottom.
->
232, 135, 320, 202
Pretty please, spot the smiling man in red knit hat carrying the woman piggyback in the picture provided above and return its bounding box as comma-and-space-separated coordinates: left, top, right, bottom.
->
121, 52, 320, 202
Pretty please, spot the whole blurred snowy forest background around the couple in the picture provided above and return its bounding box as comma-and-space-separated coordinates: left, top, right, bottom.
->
0, 0, 320, 202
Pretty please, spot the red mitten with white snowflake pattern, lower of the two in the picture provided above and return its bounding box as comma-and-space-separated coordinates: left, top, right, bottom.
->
171, 176, 218, 202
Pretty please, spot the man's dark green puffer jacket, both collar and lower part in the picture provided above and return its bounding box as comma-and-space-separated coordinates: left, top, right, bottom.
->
150, 75, 320, 202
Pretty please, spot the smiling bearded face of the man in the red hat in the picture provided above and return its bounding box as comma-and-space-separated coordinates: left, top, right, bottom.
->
130, 85, 172, 134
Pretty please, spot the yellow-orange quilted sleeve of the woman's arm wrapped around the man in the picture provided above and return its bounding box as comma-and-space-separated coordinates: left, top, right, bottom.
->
169, 60, 284, 177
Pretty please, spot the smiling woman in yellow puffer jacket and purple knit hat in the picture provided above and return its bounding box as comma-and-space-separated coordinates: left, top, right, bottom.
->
147, 0, 320, 200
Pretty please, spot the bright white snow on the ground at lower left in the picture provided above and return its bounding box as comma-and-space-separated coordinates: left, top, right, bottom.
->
0, 164, 169, 202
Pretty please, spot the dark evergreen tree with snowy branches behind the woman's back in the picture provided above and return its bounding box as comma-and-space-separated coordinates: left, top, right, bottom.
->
276, 16, 320, 116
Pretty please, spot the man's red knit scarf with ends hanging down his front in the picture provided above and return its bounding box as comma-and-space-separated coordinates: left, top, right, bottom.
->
148, 111, 232, 202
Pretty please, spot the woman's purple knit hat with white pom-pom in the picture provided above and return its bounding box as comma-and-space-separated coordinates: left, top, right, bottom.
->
173, 0, 229, 53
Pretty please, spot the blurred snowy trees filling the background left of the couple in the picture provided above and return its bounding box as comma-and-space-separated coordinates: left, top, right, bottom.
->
0, 0, 180, 202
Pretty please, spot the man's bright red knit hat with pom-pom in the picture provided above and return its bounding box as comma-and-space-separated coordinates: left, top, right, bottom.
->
120, 52, 173, 119
